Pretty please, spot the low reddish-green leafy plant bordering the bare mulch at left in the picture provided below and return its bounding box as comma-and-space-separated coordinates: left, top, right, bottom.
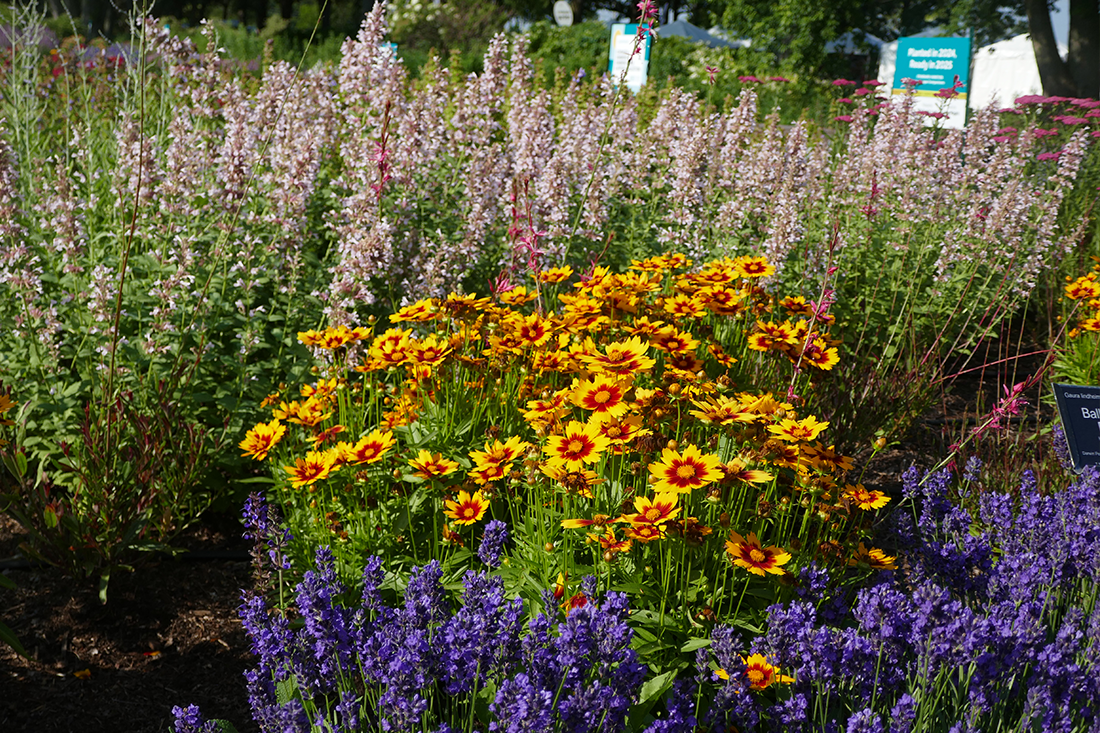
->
0, 381, 223, 600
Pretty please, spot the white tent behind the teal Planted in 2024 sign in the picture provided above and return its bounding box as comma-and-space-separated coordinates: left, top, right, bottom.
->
878, 33, 1066, 109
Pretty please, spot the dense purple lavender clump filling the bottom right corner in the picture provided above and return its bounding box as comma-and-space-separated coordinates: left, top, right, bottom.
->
763, 464, 1100, 732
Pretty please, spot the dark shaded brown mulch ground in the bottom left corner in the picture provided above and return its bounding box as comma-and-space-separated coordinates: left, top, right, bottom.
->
0, 515, 256, 733
